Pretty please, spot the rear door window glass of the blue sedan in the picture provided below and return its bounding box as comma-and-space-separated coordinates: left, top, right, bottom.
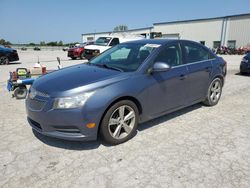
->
184, 43, 214, 63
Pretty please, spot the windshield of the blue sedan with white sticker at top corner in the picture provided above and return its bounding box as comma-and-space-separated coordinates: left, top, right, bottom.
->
89, 43, 160, 72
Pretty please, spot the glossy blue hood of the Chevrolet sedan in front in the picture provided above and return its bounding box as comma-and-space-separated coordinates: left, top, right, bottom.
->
32, 64, 131, 97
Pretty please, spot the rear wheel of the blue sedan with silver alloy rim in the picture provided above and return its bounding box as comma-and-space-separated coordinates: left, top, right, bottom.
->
203, 78, 222, 106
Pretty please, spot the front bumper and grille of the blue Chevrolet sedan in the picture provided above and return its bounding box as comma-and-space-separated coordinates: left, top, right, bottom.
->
26, 97, 101, 141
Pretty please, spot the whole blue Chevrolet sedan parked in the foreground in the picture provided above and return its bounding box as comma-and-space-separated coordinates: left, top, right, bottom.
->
26, 40, 226, 144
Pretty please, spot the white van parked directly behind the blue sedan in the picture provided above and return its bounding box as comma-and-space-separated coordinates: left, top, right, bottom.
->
84, 35, 144, 60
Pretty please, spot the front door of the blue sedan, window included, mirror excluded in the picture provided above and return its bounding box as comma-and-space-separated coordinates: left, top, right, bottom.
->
144, 42, 188, 118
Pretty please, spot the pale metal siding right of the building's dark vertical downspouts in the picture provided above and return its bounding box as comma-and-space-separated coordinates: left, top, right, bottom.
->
226, 16, 250, 47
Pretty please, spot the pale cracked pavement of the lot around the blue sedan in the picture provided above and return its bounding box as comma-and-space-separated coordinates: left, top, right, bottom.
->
0, 51, 250, 188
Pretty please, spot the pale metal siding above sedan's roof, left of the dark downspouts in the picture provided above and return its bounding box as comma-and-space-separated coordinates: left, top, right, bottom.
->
154, 19, 222, 48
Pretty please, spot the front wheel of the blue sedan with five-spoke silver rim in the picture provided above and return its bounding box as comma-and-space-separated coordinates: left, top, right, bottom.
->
100, 100, 139, 145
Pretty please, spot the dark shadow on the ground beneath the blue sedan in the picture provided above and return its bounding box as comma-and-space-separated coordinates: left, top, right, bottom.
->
33, 103, 203, 150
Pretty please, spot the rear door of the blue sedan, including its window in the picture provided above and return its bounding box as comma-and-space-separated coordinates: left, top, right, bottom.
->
182, 41, 212, 104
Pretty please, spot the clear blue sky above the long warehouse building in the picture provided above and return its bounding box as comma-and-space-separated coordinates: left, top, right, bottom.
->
0, 0, 250, 43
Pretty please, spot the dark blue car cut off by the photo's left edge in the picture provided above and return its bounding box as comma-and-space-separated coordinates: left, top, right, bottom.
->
0, 45, 19, 65
